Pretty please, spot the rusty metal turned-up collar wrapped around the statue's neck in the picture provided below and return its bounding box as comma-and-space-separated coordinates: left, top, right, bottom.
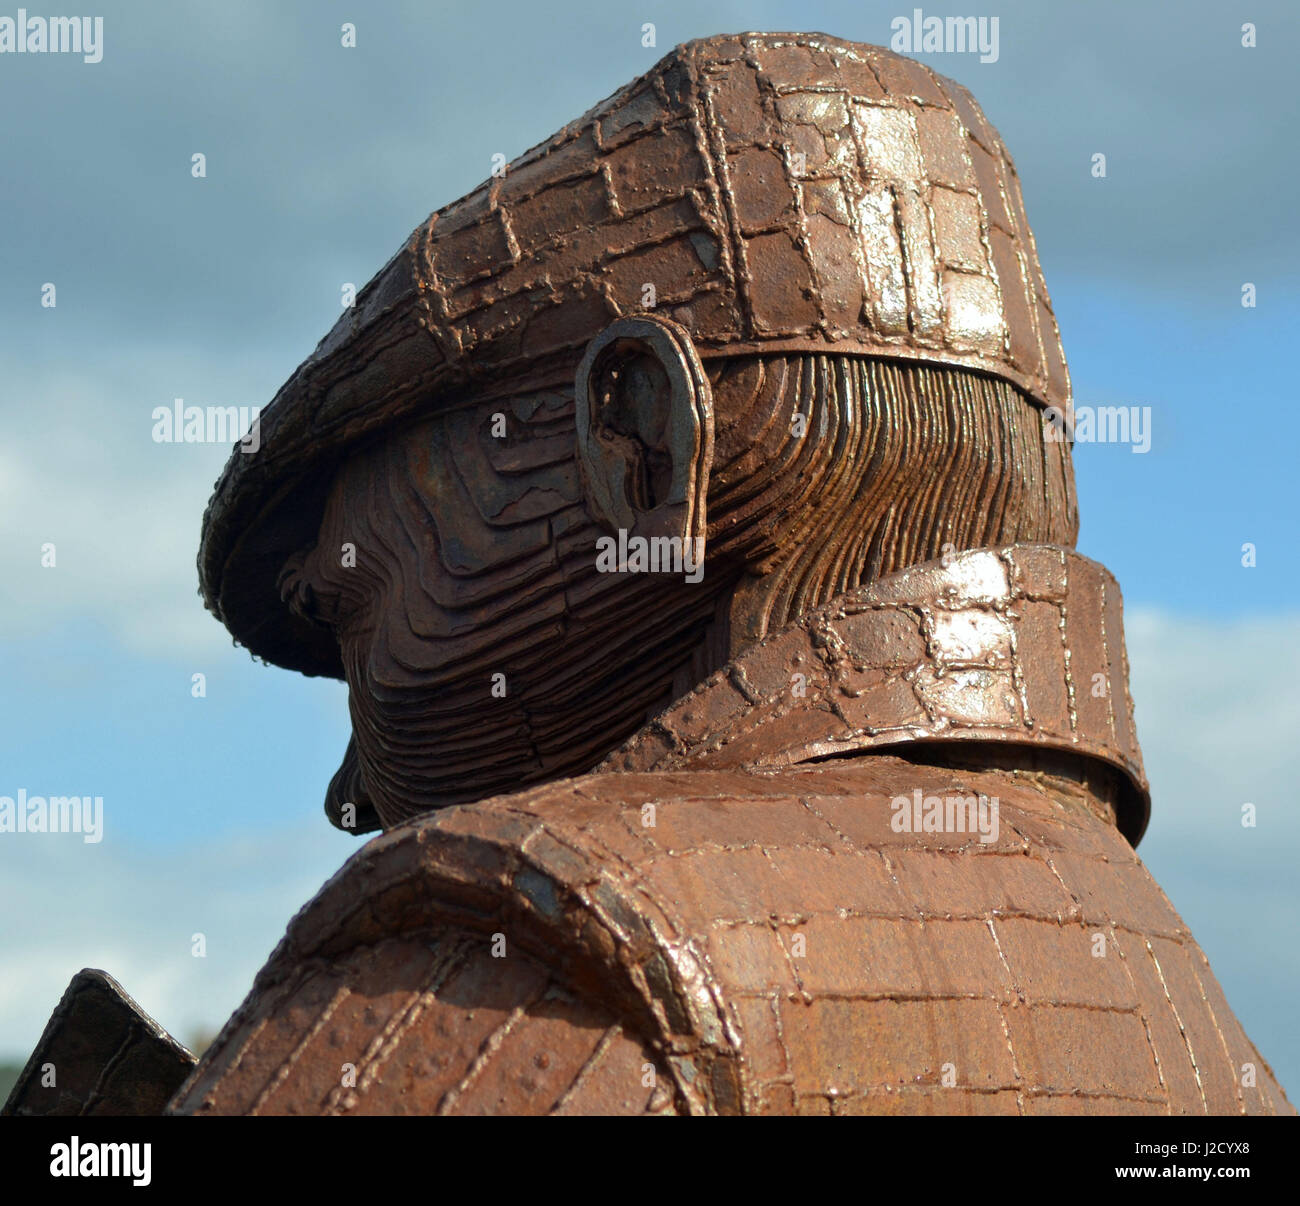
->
597, 545, 1151, 845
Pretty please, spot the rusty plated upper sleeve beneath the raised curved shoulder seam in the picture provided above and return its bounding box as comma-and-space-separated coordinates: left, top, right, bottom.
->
169, 923, 671, 1115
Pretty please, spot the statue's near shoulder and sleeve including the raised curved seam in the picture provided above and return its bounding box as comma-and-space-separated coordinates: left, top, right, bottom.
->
169, 776, 748, 1114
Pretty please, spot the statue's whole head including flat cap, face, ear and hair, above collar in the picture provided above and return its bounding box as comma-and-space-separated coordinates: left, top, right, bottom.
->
199, 34, 1078, 832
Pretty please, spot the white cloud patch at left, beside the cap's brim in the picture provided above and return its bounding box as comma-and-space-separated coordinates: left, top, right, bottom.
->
0, 359, 258, 659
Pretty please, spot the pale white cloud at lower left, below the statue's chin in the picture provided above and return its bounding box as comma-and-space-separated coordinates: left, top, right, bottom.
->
0, 823, 358, 1059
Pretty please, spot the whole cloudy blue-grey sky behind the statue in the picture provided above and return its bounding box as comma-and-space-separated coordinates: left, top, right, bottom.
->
0, 0, 1300, 1097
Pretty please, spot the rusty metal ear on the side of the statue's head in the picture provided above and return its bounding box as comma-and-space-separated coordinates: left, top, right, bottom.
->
573, 314, 714, 539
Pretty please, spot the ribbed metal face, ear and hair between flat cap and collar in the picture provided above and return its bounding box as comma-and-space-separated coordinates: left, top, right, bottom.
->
283, 343, 1076, 827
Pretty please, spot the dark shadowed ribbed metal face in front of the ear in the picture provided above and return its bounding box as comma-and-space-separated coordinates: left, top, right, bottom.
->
286, 353, 733, 825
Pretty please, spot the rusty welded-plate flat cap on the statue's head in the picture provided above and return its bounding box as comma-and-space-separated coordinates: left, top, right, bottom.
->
199, 34, 1070, 677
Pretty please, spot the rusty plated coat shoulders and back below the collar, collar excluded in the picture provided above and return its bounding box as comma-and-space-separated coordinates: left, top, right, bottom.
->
172, 755, 1288, 1114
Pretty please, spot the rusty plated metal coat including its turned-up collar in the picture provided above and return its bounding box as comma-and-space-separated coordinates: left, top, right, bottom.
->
170, 546, 1290, 1114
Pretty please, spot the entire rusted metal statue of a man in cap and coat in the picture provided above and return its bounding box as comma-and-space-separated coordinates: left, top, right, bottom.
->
7, 34, 1291, 1114
